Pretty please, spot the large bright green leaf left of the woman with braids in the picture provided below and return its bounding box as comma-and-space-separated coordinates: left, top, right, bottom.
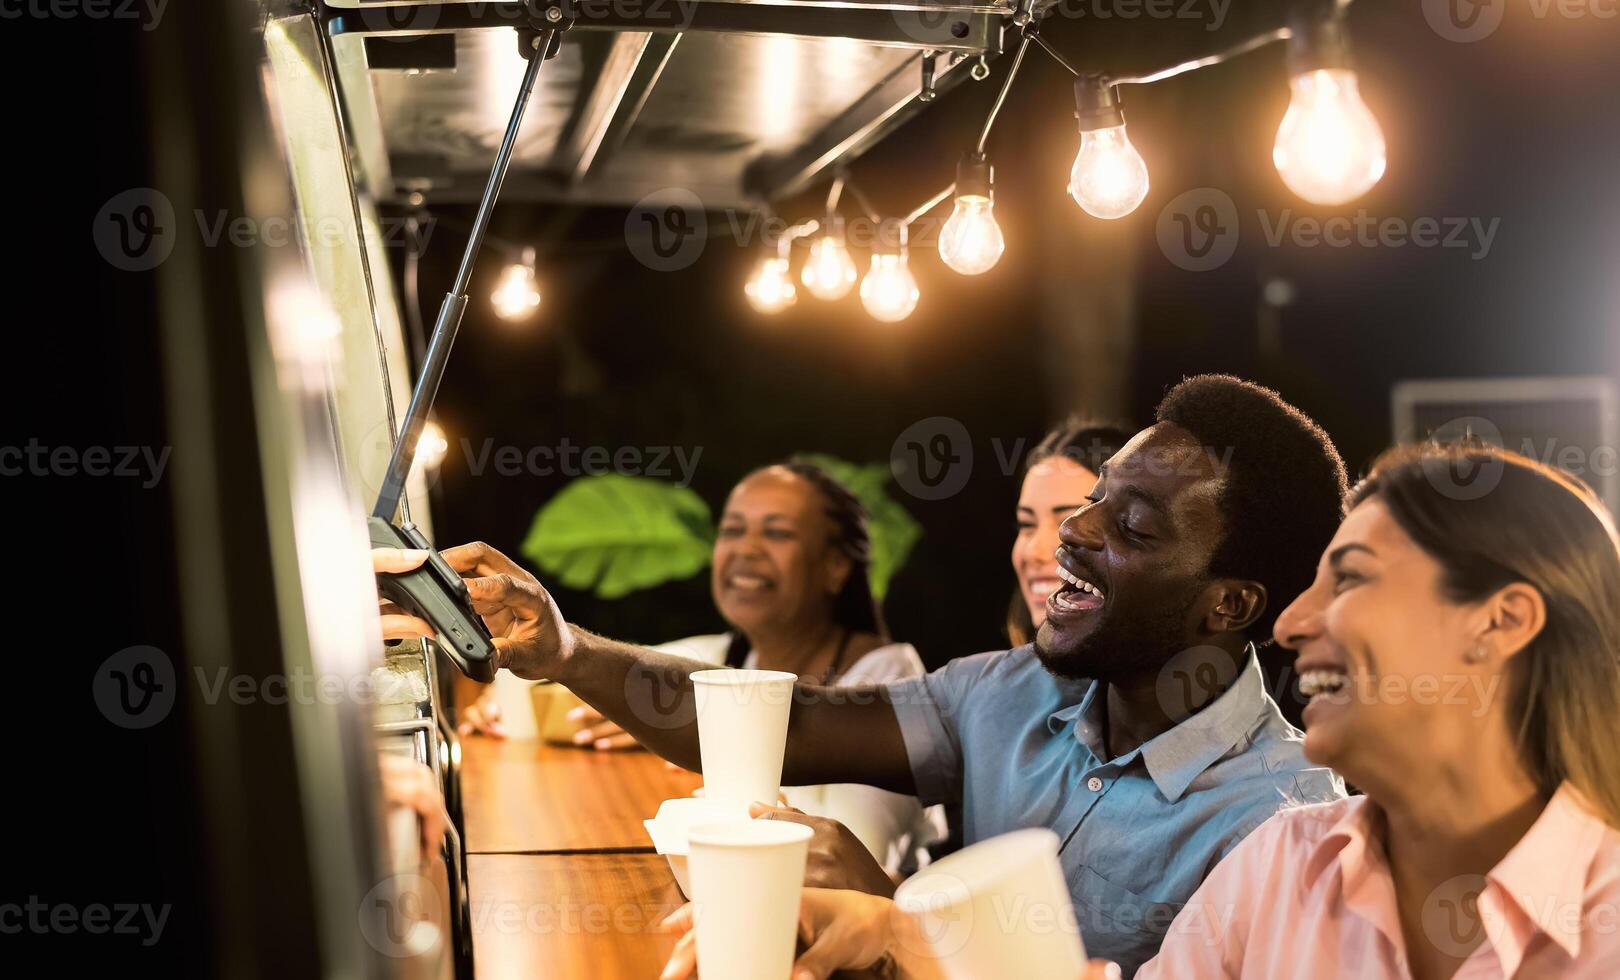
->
523, 473, 714, 599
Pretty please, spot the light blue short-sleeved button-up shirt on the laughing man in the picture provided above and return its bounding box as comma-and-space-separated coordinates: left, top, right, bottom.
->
888, 646, 1345, 977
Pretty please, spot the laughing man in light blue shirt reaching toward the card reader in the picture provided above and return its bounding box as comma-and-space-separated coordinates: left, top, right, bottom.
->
446, 376, 1346, 974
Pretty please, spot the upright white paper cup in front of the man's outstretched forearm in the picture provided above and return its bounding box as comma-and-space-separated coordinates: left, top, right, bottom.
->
692, 669, 799, 810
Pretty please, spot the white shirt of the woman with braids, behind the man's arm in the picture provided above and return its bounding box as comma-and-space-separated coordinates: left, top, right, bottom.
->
653, 633, 944, 875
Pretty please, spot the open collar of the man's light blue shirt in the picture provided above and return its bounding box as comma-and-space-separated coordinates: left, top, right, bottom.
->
1047, 645, 1270, 803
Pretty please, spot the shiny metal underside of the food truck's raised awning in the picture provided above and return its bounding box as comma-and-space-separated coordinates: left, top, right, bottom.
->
327, 0, 1013, 207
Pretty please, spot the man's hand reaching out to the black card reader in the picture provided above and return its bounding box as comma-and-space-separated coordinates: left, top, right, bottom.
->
439, 541, 573, 680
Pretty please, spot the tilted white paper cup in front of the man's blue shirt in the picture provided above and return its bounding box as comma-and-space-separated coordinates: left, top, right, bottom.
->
894, 828, 1085, 980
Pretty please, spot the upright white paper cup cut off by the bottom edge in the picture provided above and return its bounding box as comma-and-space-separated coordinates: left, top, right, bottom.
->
687, 820, 816, 980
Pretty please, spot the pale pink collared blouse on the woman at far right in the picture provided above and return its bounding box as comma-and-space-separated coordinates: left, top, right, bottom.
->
1137, 784, 1620, 980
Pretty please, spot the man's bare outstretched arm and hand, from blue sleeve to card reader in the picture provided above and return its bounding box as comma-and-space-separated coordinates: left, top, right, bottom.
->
444, 543, 915, 802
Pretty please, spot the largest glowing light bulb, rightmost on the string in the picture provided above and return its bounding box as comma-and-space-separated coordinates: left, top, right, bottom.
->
1272, 68, 1387, 204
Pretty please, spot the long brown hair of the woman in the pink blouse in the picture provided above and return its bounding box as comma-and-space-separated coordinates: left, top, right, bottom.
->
1348, 442, 1620, 828
